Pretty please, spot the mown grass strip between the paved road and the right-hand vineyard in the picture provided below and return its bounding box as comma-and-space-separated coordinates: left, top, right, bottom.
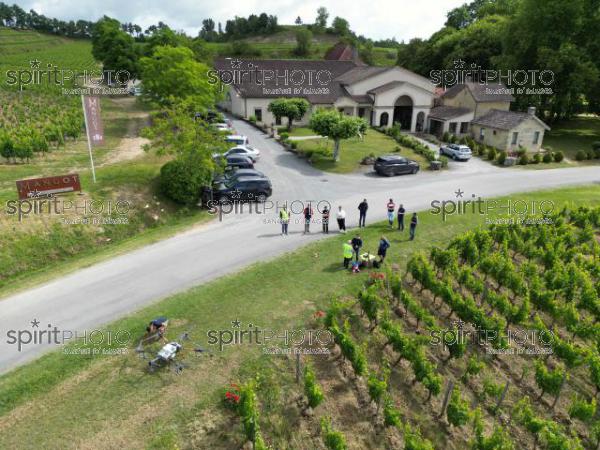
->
0, 186, 600, 449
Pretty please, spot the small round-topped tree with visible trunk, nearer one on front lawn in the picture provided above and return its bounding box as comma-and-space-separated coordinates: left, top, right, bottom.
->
309, 109, 368, 161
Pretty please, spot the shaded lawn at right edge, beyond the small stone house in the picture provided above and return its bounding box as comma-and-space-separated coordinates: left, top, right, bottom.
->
544, 116, 600, 159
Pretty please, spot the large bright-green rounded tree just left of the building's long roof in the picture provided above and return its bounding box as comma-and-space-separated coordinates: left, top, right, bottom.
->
140, 46, 219, 107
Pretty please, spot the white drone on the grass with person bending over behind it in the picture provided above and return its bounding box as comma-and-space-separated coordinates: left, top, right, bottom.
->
135, 317, 210, 375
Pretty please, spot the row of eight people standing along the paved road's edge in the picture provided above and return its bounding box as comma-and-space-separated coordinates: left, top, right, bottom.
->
279, 198, 418, 241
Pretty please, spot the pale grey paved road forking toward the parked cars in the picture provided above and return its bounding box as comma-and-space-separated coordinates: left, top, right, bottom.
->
0, 117, 600, 372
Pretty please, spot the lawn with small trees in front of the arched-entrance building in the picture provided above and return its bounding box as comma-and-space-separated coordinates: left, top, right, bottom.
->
296, 129, 429, 173
